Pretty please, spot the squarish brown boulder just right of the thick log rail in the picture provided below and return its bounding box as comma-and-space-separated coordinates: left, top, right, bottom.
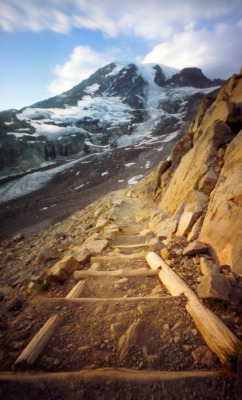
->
197, 271, 231, 301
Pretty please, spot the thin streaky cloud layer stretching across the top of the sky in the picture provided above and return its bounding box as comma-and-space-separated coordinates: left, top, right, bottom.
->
0, 0, 241, 39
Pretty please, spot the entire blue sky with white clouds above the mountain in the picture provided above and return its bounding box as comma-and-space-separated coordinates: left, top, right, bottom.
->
0, 0, 242, 110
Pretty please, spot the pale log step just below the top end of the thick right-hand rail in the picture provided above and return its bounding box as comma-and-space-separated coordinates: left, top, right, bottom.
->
74, 269, 160, 279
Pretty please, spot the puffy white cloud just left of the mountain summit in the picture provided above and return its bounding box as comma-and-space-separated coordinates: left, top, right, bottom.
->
49, 46, 119, 95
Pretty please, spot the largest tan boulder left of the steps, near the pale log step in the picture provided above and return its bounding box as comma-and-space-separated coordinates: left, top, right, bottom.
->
47, 255, 79, 281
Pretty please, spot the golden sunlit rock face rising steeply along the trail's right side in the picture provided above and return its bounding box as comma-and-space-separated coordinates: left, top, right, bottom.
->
153, 75, 242, 274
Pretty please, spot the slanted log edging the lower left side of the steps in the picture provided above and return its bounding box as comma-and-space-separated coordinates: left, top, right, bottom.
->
13, 315, 59, 368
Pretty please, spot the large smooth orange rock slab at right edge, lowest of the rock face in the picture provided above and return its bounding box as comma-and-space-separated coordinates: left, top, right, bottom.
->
199, 131, 242, 274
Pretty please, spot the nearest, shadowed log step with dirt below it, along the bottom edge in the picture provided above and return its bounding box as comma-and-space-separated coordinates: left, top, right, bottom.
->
0, 368, 233, 400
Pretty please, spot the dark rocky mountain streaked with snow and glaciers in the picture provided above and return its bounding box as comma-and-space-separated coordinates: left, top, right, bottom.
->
0, 62, 222, 203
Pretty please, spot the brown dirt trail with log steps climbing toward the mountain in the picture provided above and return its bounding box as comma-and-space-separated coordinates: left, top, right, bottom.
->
0, 192, 236, 400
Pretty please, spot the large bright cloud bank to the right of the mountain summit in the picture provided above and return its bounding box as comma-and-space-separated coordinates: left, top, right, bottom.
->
143, 24, 242, 79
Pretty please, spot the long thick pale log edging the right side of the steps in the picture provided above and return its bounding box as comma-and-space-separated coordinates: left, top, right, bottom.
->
146, 253, 240, 363
